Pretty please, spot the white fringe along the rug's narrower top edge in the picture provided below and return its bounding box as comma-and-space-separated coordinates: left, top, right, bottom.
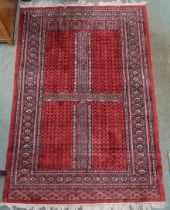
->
20, 0, 149, 7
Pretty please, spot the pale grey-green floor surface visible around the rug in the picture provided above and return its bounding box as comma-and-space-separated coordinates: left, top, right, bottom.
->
0, 0, 170, 210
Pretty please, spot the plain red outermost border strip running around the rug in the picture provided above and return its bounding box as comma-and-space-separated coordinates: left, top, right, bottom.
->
2, 5, 165, 204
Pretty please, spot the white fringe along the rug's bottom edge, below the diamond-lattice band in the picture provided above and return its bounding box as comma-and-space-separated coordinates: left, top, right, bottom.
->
0, 202, 167, 210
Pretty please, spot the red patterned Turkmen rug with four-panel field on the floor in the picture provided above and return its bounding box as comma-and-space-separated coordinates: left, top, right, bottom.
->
3, 6, 165, 210
